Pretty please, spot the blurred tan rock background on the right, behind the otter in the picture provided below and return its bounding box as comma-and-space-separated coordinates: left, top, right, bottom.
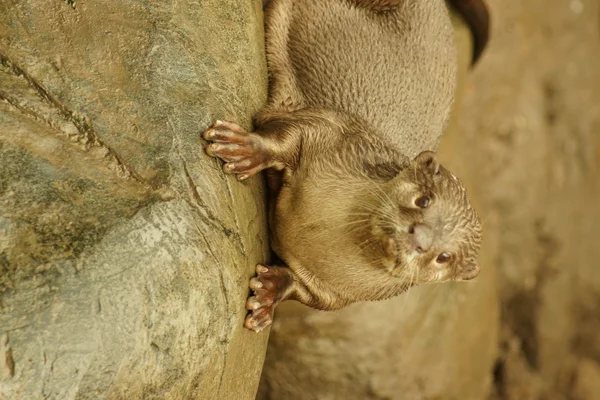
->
259, 0, 600, 400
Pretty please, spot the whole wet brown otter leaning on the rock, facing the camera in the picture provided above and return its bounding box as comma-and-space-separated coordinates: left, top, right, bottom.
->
203, 0, 487, 332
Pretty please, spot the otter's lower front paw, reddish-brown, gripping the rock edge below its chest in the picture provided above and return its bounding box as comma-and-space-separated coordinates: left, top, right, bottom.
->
244, 264, 296, 332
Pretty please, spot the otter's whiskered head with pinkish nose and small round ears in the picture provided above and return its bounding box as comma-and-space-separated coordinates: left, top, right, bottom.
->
371, 151, 481, 285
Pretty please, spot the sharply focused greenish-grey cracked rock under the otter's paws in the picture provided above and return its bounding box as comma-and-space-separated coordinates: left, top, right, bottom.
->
0, 0, 268, 399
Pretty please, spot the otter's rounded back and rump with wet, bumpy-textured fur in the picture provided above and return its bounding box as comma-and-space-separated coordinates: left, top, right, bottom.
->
265, 0, 457, 158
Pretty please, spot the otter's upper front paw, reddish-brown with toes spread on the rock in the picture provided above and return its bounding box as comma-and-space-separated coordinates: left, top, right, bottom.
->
202, 121, 271, 180
